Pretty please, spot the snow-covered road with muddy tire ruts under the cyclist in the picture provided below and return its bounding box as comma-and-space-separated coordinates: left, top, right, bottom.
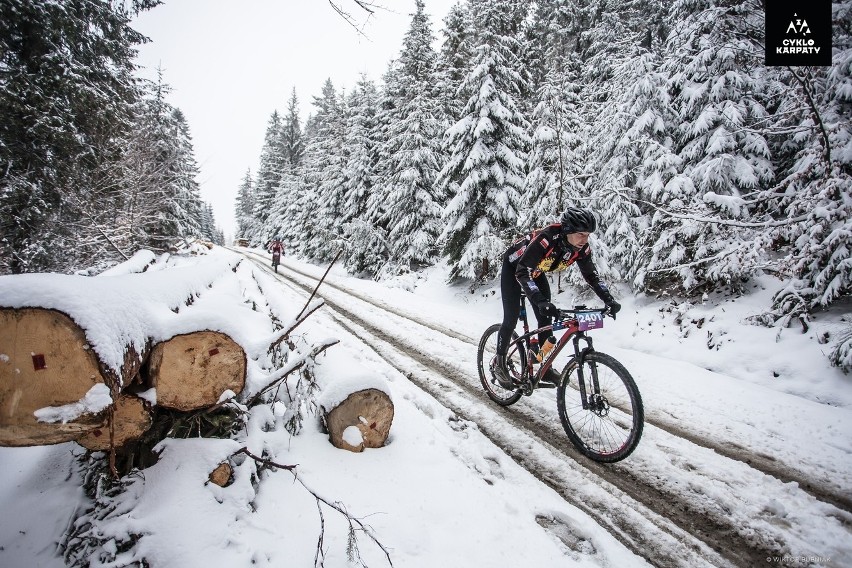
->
243, 253, 852, 566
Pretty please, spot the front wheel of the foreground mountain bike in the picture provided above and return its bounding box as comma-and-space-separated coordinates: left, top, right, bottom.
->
556, 351, 645, 463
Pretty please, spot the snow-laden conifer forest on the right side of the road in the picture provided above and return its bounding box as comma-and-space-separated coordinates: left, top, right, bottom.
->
236, 0, 852, 366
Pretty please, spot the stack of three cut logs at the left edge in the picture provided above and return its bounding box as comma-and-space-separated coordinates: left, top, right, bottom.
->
0, 307, 246, 450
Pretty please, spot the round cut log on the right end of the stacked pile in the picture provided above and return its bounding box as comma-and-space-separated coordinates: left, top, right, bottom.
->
148, 331, 246, 412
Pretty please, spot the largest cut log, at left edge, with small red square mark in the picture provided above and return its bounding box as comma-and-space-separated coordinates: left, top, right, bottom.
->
0, 308, 110, 446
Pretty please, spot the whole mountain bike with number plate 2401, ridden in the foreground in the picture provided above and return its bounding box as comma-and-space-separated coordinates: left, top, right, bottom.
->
477, 296, 644, 463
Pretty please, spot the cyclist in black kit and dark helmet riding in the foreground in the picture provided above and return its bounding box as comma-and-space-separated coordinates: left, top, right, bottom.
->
491, 207, 621, 389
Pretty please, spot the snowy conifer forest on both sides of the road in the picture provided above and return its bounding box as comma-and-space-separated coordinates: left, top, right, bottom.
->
0, 0, 852, 367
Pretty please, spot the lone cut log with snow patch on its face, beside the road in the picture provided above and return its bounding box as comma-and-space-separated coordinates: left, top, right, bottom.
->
323, 389, 393, 452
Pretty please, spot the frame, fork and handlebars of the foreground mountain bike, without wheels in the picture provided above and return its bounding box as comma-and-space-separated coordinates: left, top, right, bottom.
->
510, 296, 606, 410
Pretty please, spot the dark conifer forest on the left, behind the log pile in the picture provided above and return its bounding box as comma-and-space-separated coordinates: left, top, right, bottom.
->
0, 0, 224, 274
